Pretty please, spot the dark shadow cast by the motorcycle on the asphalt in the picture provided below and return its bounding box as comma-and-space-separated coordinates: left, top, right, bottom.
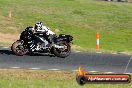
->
0, 49, 55, 57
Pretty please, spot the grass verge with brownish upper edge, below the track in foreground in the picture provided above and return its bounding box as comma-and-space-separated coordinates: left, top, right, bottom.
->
0, 69, 132, 88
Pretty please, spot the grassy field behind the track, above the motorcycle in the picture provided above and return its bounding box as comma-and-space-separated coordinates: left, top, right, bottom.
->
0, 0, 132, 52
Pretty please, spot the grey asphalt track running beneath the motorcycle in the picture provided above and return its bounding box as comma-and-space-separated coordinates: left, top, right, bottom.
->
0, 48, 132, 73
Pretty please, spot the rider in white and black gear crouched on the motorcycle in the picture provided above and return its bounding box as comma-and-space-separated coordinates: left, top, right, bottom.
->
29, 22, 56, 51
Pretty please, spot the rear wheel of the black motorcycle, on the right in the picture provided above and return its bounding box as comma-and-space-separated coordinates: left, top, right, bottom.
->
53, 42, 71, 58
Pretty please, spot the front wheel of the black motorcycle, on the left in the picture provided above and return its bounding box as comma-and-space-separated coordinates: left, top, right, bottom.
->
11, 40, 28, 56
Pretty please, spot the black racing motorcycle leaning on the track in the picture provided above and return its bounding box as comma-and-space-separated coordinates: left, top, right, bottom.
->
11, 28, 73, 58
